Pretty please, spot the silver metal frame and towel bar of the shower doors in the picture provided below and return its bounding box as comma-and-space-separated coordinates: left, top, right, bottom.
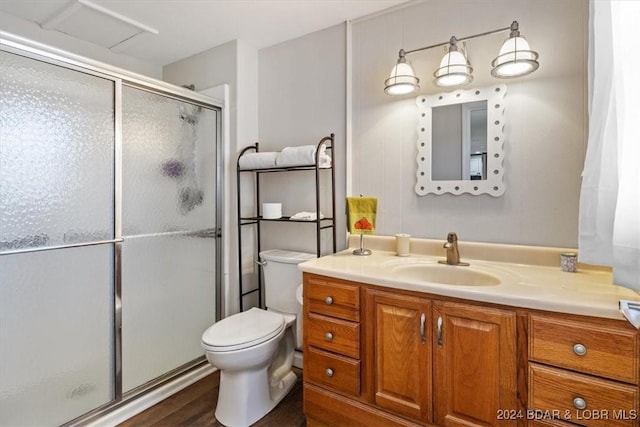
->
0, 31, 224, 426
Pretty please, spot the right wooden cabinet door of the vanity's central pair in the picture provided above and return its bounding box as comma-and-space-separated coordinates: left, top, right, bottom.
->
433, 301, 517, 427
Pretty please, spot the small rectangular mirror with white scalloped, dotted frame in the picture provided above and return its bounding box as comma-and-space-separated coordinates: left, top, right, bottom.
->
415, 84, 507, 197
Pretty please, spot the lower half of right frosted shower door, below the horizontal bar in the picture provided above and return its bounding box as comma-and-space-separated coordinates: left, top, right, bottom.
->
122, 234, 215, 393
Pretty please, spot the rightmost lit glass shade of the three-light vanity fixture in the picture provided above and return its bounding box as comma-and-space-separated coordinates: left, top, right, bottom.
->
491, 36, 540, 78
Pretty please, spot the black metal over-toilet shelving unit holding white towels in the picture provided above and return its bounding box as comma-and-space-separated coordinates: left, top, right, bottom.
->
236, 133, 336, 311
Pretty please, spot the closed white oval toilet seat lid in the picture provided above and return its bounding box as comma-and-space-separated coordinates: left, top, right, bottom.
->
202, 307, 285, 352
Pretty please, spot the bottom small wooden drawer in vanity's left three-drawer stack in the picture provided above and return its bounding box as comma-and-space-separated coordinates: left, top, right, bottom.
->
303, 347, 360, 396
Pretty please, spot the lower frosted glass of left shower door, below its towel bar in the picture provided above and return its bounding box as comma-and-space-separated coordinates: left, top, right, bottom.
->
0, 245, 114, 427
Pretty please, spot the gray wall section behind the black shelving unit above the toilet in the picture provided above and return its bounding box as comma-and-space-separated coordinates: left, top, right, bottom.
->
258, 25, 346, 253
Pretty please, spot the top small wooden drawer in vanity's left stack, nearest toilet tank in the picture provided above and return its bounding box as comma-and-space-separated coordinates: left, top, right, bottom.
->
304, 275, 360, 322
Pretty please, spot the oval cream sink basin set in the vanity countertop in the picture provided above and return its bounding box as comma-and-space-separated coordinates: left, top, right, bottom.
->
391, 263, 501, 286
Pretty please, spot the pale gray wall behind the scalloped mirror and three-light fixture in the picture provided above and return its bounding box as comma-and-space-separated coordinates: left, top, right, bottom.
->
348, 0, 588, 247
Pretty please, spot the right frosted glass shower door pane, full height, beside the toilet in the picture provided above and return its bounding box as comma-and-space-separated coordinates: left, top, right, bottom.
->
122, 87, 217, 393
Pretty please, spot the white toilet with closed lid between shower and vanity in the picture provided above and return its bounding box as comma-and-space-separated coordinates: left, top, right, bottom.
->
202, 249, 315, 427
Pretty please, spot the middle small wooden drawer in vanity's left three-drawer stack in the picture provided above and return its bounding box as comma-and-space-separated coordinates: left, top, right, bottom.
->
307, 313, 360, 359
